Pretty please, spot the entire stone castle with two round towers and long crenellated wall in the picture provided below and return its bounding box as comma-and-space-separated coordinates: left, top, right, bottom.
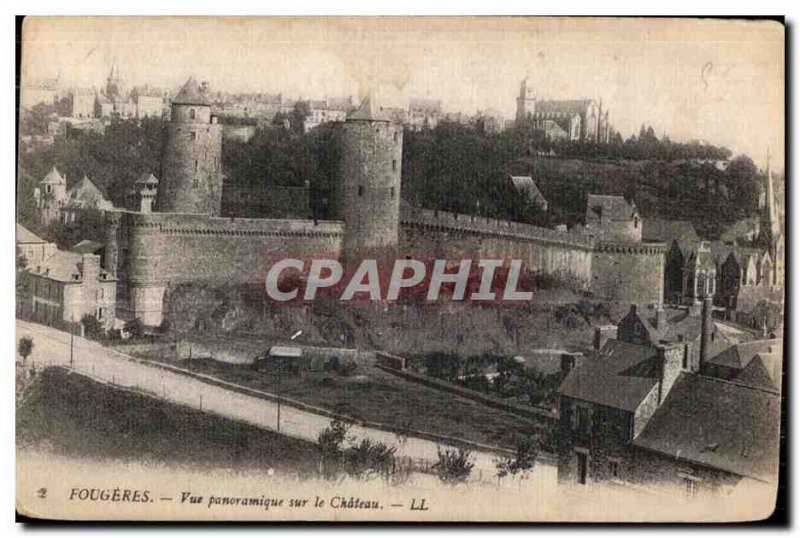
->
106, 79, 665, 326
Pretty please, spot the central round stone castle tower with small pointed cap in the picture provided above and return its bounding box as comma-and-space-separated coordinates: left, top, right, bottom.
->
339, 96, 403, 262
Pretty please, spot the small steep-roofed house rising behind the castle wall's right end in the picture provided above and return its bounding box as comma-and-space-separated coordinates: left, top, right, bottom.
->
584, 194, 642, 243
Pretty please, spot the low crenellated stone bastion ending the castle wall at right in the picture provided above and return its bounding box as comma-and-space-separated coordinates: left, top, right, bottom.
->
590, 243, 666, 304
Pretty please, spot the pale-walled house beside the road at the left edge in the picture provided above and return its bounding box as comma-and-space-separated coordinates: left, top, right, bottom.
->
20, 250, 117, 329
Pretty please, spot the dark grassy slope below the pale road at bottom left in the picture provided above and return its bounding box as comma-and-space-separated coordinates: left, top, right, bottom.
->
17, 368, 319, 476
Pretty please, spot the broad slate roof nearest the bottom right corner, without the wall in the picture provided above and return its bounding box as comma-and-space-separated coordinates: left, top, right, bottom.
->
633, 373, 780, 482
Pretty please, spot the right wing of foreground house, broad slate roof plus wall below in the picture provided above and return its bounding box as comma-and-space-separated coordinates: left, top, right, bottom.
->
619, 373, 781, 492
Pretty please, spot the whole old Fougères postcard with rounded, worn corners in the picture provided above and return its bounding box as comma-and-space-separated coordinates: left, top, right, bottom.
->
15, 17, 786, 522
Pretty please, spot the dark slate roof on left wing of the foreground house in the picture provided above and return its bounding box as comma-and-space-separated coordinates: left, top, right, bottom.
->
559, 340, 658, 412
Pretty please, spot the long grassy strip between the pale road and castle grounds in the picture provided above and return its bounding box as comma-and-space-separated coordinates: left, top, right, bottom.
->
142, 359, 543, 447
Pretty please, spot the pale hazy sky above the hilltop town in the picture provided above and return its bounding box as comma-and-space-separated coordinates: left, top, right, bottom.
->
21, 17, 784, 170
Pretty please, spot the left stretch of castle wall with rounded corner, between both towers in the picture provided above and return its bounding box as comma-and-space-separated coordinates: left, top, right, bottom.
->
118, 213, 342, 326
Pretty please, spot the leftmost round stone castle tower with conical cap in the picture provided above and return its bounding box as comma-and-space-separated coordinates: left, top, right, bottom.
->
157, 78, 222, 216
